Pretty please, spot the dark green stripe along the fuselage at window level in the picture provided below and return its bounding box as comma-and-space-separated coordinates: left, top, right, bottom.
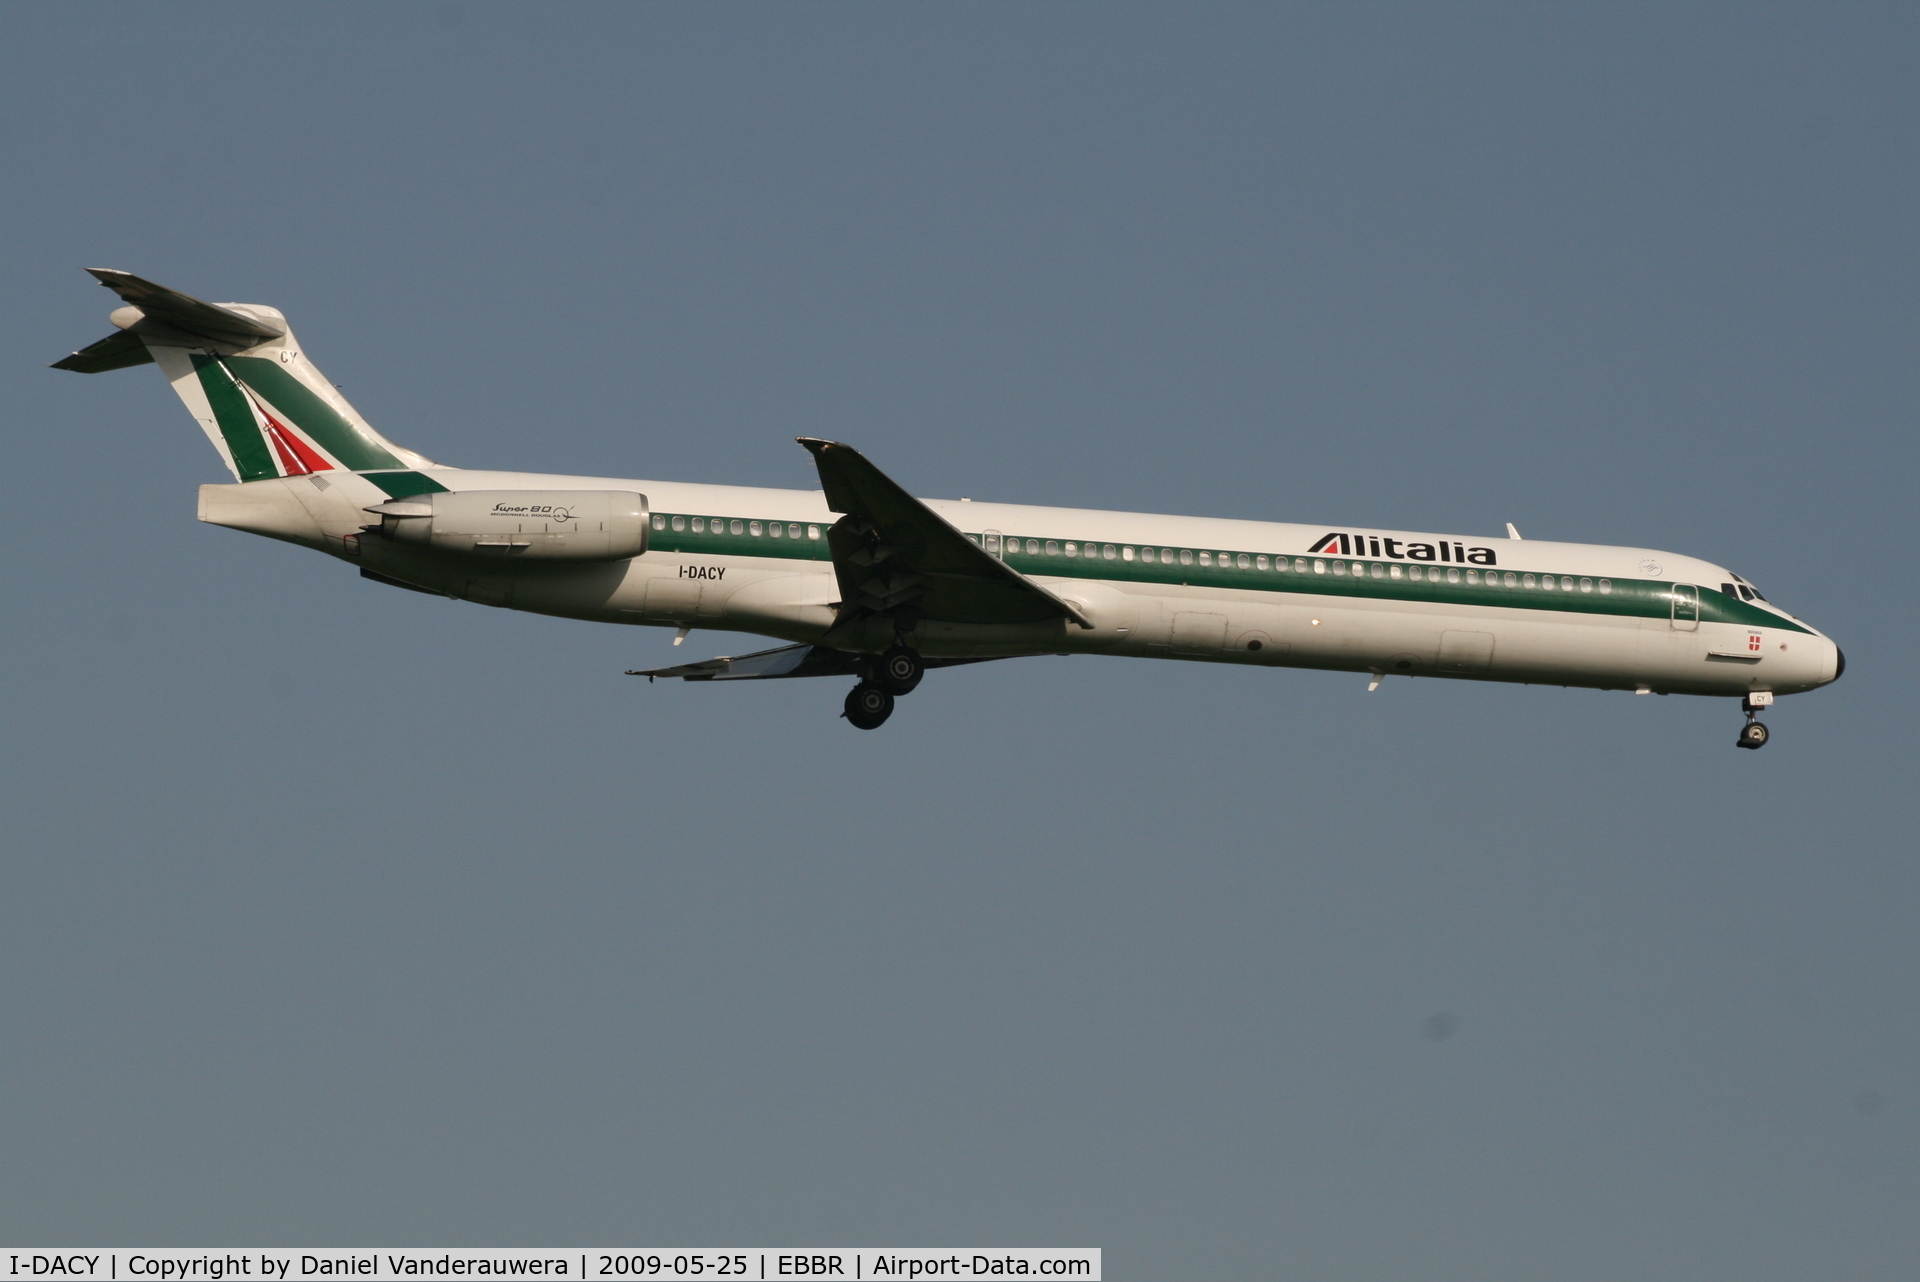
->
647, 512, 1809, 631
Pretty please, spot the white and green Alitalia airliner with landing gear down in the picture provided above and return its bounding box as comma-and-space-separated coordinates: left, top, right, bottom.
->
54, 269, 1847, 748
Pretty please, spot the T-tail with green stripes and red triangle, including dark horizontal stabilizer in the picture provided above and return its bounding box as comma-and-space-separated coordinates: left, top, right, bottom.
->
54, 267, 434, 482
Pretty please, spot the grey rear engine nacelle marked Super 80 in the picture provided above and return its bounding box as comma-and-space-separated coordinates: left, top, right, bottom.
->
367, 489, 647, 560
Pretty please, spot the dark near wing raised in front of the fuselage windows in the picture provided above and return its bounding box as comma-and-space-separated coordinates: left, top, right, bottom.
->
799, 436, 1092, 628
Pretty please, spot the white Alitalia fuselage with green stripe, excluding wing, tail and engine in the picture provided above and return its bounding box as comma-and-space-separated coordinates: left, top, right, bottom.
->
200, 468, 1843, 697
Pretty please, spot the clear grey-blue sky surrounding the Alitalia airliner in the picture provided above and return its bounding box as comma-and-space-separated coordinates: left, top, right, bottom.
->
0, 4, 1920, 1282
